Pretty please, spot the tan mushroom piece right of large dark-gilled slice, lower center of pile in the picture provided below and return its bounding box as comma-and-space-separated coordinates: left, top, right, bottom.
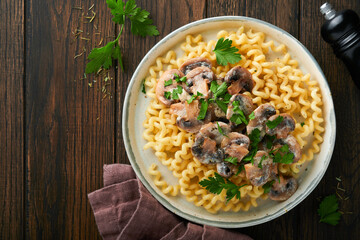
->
221, 132, 250, 162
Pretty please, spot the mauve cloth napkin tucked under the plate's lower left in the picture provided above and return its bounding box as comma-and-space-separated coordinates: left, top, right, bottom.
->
88, 164, 251, 240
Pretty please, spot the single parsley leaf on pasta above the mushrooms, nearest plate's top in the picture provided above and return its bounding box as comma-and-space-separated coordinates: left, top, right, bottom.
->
213, 38, 241, 66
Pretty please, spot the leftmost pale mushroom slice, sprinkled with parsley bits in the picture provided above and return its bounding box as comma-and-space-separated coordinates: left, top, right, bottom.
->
155, 69, 184, 106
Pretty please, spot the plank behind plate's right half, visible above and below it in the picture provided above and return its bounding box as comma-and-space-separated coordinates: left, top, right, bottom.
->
207, 0, 303, 239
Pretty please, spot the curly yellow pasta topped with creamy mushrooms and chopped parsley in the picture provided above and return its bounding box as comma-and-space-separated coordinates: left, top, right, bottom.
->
143, 27, 324, 213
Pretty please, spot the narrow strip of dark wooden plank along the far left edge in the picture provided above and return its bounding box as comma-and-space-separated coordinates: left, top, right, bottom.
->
0, 0, 25, 239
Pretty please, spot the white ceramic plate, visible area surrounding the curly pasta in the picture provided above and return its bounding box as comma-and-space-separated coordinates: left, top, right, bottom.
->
122, 16, 336, 228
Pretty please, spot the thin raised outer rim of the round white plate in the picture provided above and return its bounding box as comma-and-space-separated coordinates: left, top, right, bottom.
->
122, 16, 336, 228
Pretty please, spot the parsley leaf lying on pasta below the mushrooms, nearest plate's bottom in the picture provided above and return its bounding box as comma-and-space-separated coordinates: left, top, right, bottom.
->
199, 173, 246, 202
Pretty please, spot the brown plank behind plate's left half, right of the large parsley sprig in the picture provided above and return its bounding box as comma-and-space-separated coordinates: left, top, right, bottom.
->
115, 0, 206, 163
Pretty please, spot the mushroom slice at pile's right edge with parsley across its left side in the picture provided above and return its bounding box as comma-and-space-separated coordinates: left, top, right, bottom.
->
266, 113, 295, 138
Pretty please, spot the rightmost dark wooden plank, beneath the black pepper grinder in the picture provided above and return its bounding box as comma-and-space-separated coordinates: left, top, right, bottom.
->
299, 0, 360, 239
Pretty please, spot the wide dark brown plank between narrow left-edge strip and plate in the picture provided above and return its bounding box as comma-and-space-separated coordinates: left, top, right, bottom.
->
25, 0, 114, 239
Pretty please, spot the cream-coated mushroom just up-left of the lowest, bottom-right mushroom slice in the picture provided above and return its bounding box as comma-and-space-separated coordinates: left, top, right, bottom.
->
244, 151, 278, 186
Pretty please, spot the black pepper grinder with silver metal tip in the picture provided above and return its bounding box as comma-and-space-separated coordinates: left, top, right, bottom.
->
320, 3, 360, 89
